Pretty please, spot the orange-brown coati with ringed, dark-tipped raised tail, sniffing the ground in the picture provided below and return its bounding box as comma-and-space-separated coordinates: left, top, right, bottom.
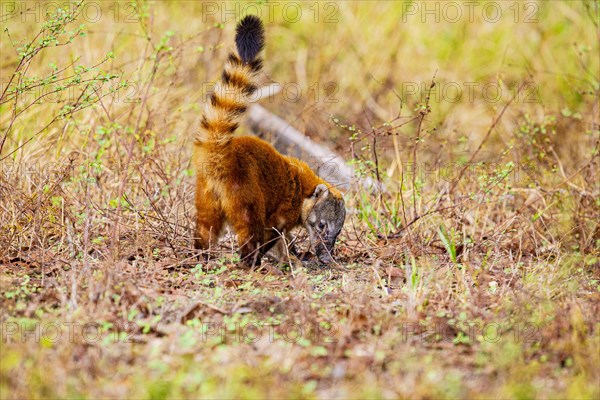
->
194, 15, 346, 266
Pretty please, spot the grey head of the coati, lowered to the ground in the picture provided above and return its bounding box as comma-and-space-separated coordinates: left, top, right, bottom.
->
302, 184, 346, 264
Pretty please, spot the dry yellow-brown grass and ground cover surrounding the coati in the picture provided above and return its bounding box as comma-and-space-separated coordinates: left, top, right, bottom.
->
0, 2, 600, 399
